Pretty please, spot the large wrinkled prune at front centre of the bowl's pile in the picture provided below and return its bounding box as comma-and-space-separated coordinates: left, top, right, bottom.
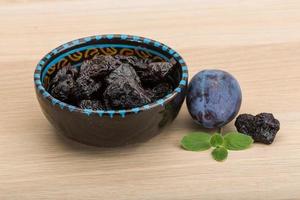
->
103, 64, 151, 109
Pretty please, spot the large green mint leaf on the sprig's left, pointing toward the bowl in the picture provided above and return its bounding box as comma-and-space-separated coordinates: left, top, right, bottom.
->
181, 132, 211, 151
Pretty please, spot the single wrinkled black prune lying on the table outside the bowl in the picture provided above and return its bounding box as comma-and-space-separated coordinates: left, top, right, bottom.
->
235, 113, 280, 144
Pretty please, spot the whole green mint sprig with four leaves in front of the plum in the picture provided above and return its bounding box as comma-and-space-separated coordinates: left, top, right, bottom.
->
181, 132, 253, 161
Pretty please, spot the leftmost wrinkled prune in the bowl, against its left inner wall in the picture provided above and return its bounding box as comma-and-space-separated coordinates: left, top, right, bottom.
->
49, 65, 78, 102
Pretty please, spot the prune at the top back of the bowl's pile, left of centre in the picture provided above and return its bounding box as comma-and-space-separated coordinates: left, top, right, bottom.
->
80, 55, 121, 78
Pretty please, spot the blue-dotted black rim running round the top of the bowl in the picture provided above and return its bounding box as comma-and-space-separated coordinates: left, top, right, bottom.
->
34, 34, 188, 118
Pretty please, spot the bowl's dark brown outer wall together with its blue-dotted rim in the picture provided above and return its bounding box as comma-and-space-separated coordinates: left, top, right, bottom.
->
34, 34, 188, 147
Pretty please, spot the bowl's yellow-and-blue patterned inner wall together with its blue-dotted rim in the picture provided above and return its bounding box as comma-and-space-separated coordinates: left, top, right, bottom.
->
34, 34, 188, 116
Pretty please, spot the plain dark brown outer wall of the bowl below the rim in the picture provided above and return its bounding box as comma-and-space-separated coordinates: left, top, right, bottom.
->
36, 86, 187, 147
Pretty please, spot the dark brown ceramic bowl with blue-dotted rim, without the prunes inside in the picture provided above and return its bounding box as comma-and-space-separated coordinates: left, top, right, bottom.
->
34, 34, 188, 147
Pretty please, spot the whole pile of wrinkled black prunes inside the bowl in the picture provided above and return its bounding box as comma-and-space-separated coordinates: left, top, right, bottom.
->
48, 55, 174, 110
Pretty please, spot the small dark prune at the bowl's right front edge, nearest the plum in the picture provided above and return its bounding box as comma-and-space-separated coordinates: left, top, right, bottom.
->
146, 83, 173, 101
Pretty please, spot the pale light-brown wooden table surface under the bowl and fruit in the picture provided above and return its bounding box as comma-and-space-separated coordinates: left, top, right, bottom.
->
0, 0, 300, 200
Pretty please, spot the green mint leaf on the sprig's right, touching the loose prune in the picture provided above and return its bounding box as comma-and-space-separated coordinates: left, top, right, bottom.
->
224, 132, 253, 151
